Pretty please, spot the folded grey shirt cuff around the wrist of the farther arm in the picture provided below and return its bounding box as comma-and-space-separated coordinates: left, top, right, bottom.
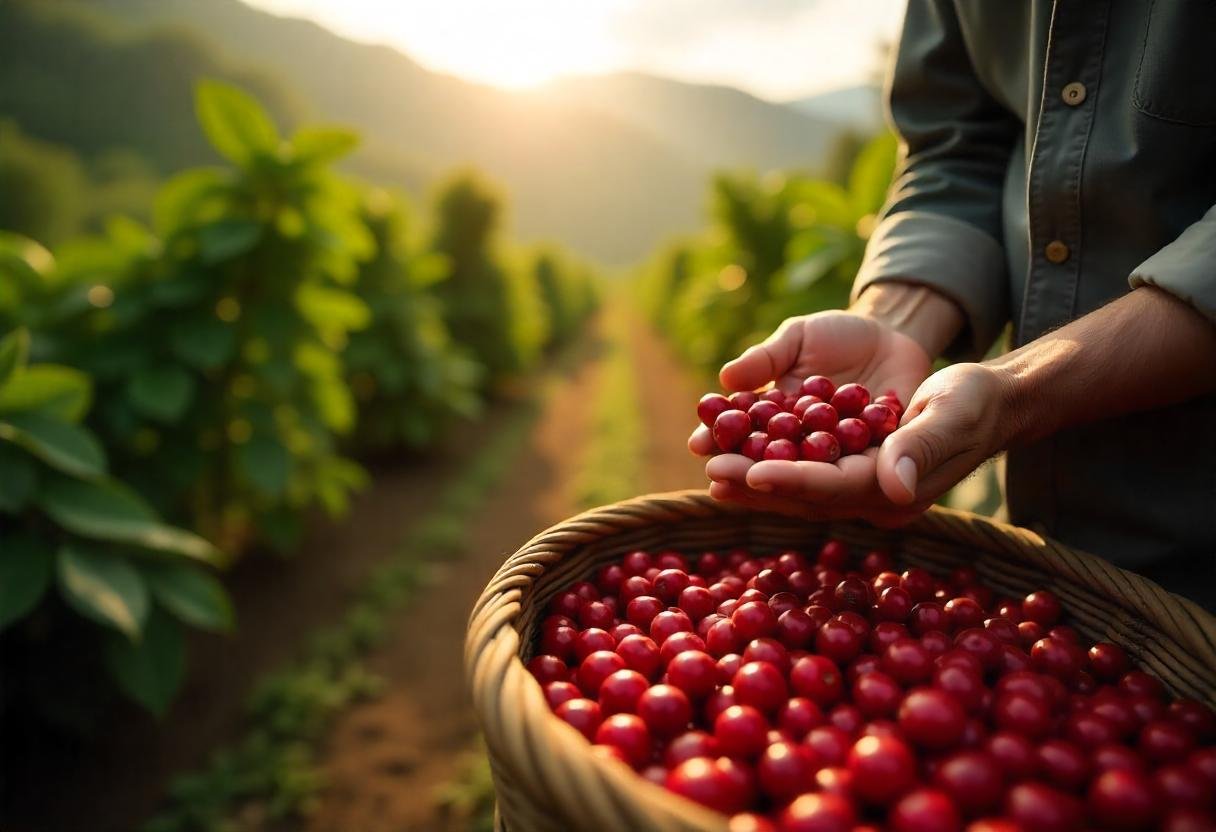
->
852, 210, 1009, 360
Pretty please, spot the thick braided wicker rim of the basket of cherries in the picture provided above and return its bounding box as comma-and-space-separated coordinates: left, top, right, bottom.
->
466, 489, 1216, 830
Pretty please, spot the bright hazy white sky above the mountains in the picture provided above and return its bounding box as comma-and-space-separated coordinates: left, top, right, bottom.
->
246, 0, 903, 100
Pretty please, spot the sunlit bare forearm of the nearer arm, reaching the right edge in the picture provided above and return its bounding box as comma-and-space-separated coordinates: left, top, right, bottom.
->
989, 287, 1216, 445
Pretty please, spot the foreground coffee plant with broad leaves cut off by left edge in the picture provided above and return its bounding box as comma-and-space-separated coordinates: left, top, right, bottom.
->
0, 330, 232, 713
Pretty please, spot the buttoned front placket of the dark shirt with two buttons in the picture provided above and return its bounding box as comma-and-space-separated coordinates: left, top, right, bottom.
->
1017, 0, 1109, 343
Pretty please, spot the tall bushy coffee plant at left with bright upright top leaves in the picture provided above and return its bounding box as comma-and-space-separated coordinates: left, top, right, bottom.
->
35, 83, 375, 549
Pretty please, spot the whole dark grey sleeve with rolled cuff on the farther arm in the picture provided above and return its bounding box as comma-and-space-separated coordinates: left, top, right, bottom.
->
852, 0, 1023, 358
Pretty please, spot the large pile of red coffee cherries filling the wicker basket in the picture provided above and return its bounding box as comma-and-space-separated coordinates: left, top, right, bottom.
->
528, 541, 1216, 832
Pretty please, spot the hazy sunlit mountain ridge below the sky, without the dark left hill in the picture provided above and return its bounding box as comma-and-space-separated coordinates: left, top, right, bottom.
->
42, 0, 838, 264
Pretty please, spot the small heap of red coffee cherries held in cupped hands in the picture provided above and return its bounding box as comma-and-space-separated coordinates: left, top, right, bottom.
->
697, 376, 903, 462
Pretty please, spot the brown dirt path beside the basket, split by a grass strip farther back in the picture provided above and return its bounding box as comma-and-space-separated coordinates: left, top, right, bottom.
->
295, 308, 704, 832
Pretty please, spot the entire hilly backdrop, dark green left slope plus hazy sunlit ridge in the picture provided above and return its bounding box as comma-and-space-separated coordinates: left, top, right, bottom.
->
0, 0, 839, 263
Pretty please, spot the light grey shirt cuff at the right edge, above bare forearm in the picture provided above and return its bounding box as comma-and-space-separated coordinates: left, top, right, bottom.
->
1127, 208, 1216, 324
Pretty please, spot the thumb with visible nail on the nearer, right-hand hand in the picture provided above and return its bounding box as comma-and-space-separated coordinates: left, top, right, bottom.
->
877, 398, 963, 506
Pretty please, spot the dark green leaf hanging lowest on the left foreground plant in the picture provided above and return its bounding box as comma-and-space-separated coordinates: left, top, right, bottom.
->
105, 609, 186, 716
